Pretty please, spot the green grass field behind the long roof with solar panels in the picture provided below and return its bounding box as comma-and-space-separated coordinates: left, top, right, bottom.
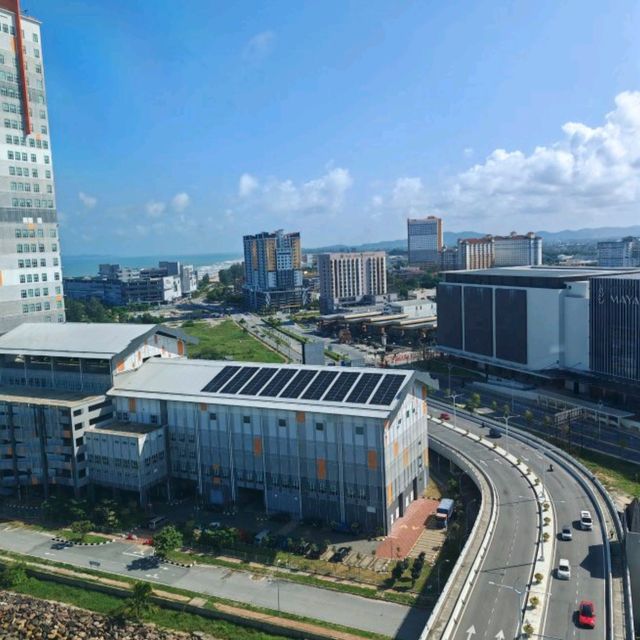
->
183, 320, 285, 363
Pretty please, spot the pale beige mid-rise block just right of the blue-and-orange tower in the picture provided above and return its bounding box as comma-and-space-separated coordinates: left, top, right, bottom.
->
318, 251, 387, 313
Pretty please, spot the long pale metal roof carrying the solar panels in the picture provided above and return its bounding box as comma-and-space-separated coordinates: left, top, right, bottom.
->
108, 358, 414, 418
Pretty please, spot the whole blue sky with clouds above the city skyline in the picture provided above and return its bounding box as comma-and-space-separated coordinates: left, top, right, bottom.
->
28, 0, 640, 255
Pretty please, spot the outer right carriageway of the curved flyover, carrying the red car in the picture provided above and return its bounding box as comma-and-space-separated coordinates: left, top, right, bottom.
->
436, 416, 606, 637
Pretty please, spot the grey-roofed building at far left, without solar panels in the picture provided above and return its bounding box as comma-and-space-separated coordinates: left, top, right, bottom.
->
0, 323, 187, 497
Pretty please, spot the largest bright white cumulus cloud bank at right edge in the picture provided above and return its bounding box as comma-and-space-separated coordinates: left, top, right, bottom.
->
429, 91, 640, 230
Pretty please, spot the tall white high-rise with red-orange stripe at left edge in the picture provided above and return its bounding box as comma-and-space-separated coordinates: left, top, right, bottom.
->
0, 0, 65, 334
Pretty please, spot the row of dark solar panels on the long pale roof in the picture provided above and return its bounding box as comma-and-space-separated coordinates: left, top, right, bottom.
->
202, 365, 406, 406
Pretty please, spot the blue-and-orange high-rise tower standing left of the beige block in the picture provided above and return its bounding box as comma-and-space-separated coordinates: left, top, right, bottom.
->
244, 229, 307, 311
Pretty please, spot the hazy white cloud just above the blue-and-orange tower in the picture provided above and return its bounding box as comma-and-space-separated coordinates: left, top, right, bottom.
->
240, 167, 353, 214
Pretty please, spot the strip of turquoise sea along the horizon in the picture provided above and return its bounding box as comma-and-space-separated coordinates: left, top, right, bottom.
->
61, 253, 243, 277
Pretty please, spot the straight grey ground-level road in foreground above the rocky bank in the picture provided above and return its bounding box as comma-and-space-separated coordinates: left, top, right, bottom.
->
0, 524, 428, 640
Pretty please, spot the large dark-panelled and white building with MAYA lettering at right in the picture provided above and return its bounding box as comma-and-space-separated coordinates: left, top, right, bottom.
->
437, 267, 640, 382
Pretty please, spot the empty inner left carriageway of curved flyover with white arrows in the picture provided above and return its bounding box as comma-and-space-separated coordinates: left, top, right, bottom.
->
434, 425, 537, 640
